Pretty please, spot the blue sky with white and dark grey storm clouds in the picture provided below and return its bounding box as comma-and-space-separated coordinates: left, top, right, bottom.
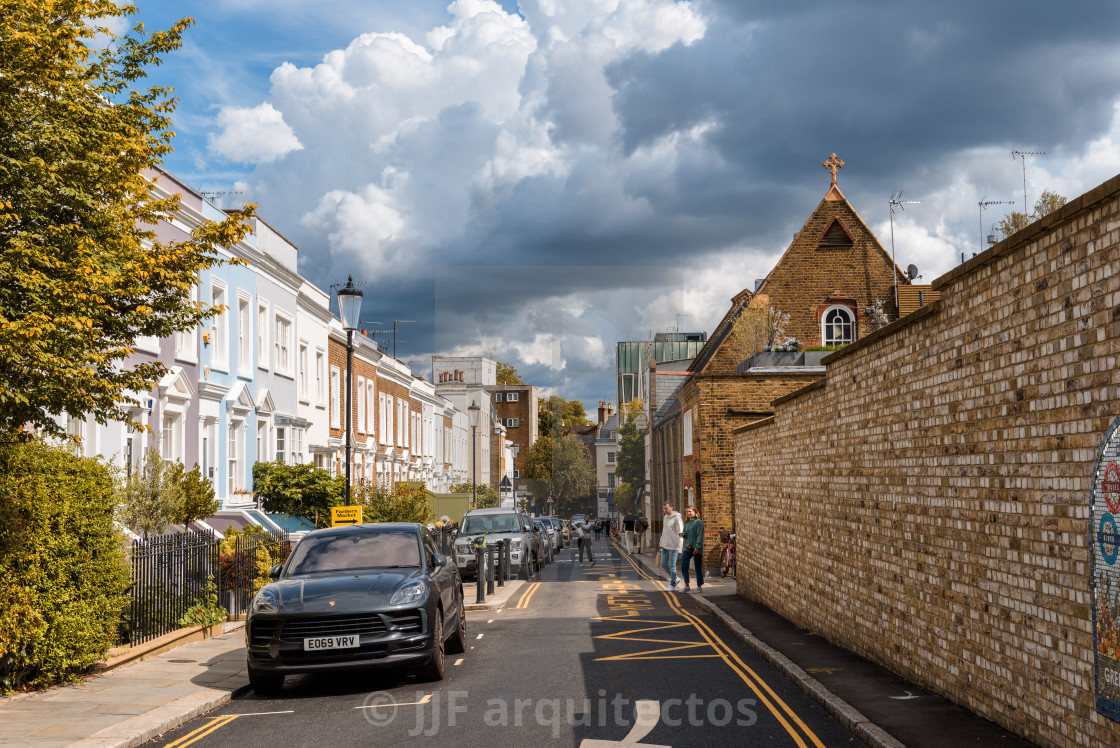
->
127, 0, 1120, 409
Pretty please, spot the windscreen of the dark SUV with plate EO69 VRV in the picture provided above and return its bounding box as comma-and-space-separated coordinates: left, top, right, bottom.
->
284, 532, 420, 577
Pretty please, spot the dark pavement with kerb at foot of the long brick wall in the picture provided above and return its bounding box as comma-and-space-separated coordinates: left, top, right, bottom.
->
631, 537, 1035, 748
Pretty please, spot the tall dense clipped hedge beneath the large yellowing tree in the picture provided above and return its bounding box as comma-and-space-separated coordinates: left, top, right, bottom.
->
0, 441, 129, 692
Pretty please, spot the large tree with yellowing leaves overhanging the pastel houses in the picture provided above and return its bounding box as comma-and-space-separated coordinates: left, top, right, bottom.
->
0, 0, 253, 439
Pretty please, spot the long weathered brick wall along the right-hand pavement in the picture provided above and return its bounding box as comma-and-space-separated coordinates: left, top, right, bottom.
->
735, 177, 1120, 747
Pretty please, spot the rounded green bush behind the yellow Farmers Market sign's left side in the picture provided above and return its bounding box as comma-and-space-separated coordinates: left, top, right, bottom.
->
253, 462, 346, 527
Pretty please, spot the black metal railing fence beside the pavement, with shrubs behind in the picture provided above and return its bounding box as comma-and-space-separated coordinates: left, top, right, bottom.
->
120, 532, 291, 645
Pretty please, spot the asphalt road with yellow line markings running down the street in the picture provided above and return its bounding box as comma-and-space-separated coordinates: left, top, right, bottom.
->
151, 542, 864, 748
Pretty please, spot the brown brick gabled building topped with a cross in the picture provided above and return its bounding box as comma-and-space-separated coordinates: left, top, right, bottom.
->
650, 159, 909, 567
